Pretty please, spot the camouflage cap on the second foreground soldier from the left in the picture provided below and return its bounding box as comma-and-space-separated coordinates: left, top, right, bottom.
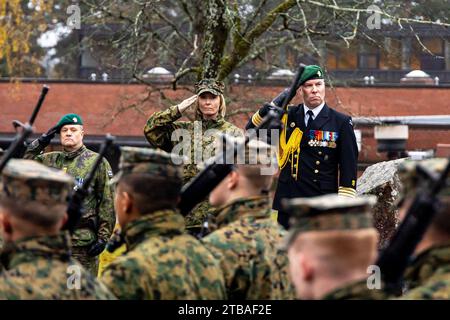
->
110, 147, 186, 184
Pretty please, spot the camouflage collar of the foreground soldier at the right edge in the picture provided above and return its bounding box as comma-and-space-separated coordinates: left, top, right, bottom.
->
405, 243, 450, 288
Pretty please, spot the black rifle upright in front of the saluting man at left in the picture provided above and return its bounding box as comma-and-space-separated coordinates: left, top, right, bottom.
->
63, 133, 115, 234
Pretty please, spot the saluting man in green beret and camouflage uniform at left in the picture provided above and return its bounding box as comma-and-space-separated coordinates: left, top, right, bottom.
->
25, 114, 116, 275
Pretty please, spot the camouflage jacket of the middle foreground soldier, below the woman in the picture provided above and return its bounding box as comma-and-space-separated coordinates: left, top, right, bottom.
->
202, 196, 295, 300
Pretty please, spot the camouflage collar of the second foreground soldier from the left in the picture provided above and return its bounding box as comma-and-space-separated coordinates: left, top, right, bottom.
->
124, 209, 185, 250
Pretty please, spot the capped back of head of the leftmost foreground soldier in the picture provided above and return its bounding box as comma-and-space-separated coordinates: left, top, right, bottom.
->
0, 159, 74, 228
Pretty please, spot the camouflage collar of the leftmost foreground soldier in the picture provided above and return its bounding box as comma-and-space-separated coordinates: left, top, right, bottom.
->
1, 232, 70, 269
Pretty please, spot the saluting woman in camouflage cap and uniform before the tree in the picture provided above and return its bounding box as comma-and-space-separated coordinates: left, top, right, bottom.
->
144, 79, 242, 233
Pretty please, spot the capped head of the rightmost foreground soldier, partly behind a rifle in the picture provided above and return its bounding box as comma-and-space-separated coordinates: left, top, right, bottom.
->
398, 158, 450, 238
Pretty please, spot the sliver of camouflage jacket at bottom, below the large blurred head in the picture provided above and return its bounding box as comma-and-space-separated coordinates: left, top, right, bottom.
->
322, 279, 388, 300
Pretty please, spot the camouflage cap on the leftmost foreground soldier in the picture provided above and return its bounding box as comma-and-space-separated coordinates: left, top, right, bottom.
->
0, 159, 75, 205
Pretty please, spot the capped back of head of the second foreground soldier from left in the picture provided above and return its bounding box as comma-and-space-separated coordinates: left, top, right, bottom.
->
111, 147, 183, 214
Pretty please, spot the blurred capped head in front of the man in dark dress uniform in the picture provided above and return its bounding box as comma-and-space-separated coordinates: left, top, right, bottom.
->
284, 194, 378, 277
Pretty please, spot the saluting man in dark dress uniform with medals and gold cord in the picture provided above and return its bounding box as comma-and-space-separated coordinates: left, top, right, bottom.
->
246, 65, 358, 228
